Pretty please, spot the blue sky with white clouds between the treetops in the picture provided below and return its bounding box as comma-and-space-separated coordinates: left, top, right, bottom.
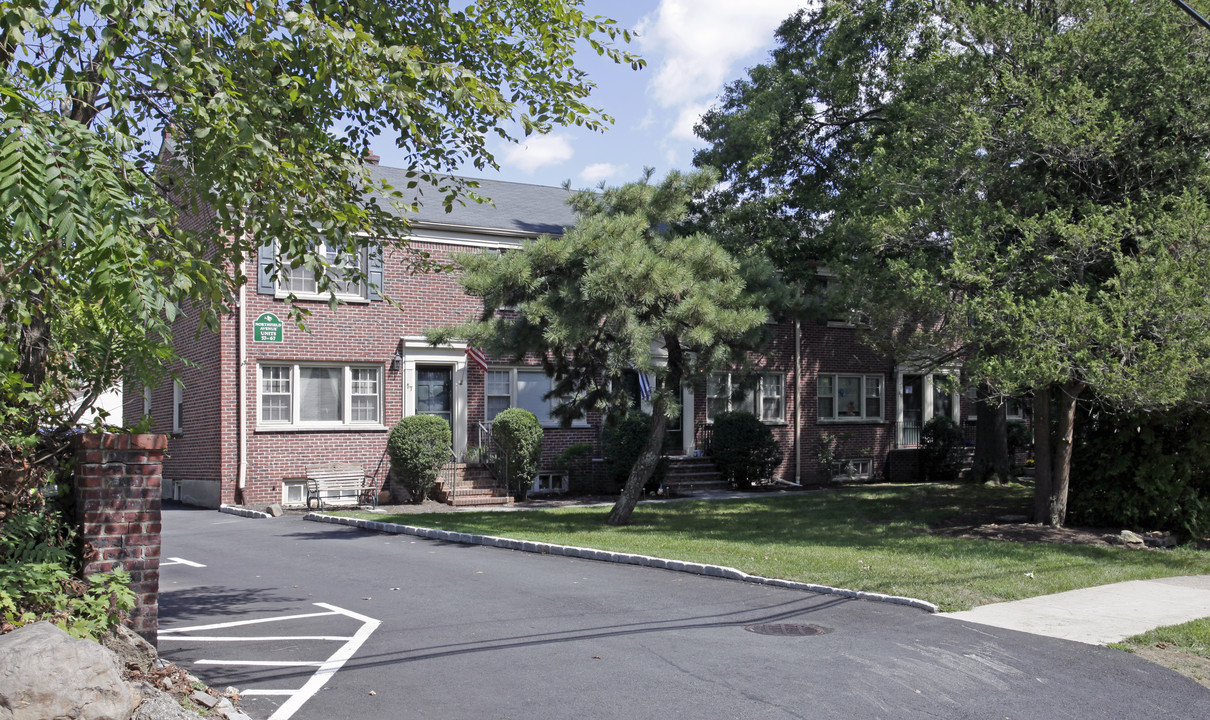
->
363, 0, 808, 188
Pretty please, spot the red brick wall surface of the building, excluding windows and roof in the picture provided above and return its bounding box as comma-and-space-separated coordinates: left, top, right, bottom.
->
126, 170, 968, 505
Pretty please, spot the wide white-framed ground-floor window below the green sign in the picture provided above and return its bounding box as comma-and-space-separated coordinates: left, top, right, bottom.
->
258, 363, 382, 428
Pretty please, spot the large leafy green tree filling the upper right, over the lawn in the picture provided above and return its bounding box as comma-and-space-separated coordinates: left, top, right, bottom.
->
697, 0, 1210, 525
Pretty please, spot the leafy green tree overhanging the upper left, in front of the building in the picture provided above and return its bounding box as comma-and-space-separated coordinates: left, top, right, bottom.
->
0, 0, 643, 479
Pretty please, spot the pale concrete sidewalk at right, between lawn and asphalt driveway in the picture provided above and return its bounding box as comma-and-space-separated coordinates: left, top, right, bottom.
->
939, 575, 1210, 645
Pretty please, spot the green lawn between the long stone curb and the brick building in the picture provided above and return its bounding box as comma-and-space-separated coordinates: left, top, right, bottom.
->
338, 485, 1210, 611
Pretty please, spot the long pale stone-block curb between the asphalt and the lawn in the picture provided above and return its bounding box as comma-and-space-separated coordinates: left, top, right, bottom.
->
300, 513, 939, 612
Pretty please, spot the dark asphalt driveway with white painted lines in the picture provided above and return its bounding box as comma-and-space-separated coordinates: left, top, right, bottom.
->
160, 507, 1210, 720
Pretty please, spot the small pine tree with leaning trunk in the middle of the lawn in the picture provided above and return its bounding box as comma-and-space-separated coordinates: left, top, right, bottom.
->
430, 171, 776, 525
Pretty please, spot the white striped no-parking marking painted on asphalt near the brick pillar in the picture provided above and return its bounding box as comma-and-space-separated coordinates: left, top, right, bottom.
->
160, 600, 381, 720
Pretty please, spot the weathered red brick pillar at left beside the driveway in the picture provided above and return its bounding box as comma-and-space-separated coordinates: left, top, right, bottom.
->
75, 433, 168, 645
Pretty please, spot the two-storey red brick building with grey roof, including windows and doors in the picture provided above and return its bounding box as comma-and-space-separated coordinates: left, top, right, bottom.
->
125, 160, 962, 507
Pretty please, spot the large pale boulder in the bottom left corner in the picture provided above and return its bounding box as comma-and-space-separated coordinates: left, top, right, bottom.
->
0, 622, 143, 720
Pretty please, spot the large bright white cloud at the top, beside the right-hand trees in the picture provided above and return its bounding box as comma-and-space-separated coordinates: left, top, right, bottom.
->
638, 0, 809, 108
